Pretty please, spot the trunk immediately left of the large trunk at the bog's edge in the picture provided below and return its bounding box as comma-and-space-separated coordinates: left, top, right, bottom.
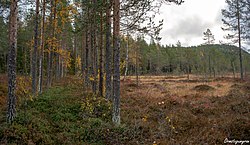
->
105, 0, 112, 100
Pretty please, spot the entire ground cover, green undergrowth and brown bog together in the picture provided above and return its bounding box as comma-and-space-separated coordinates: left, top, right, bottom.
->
0, 75, 250, 145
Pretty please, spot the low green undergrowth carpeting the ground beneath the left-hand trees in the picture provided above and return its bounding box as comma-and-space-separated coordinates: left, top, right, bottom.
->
0, 86, 133, 144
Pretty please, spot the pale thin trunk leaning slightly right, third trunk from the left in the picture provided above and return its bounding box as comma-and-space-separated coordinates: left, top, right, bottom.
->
38, 0, 45, 94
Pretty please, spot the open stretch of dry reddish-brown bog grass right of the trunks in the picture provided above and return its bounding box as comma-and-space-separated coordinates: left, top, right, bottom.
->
121, 76, 250, 144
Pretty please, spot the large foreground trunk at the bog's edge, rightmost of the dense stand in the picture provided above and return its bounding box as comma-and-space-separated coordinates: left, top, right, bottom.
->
112, 0, 121, 125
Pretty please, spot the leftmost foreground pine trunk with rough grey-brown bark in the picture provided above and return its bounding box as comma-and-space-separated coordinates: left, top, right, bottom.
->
7, 0, 18, 123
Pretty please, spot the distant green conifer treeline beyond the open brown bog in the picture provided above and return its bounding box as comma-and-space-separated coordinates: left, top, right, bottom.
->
118, 38, 250, 77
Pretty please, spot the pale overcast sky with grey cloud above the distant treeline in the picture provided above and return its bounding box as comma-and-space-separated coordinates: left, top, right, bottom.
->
159, 0, 225, 46
